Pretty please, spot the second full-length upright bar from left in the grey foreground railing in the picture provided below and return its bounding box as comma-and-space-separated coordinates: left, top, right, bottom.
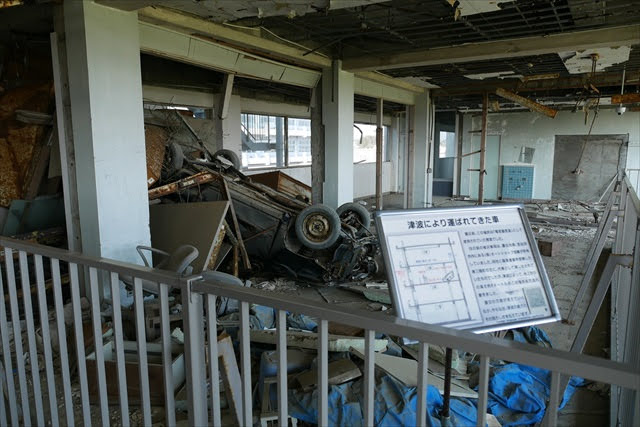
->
18, 251, 44, 425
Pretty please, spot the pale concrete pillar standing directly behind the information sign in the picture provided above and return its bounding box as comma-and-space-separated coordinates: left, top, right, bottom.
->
407, 92, 433, 208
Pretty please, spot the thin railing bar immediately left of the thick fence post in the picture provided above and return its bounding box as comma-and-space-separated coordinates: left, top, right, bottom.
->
159, 283, 176, 426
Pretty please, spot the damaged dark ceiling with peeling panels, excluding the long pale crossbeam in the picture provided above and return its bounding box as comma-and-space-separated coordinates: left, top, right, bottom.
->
0, 0, 640, 109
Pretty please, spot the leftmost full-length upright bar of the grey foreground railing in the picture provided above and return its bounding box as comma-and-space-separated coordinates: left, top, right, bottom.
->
4, 247, 31, 425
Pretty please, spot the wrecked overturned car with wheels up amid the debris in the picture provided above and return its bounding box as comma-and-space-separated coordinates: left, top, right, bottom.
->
149, 143, 381, 283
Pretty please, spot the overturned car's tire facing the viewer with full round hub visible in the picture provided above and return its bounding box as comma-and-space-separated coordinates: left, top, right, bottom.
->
295, 204, 341, 249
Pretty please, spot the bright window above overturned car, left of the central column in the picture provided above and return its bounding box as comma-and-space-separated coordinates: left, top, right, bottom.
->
241, 114, 311, 169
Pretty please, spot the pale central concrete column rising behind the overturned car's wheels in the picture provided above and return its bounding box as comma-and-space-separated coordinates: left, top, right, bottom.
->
322, 61, 353, 208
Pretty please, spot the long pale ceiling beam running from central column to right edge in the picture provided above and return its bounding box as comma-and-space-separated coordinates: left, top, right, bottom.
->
342, 24, 640, 72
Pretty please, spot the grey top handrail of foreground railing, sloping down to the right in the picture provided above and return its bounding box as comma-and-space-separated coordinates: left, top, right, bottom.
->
0, 237, 640, 390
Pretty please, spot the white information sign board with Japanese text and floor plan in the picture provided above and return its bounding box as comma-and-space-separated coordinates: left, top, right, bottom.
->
375, 205, 560, 333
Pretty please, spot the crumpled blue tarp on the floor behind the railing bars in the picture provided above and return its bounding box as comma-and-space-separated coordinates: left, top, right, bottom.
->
274, 327, 584, 426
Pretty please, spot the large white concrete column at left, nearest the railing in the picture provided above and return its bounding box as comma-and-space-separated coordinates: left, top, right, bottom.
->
62, 0, 150, 263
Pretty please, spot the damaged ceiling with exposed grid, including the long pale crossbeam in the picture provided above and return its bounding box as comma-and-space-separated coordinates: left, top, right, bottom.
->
0, 0, 640, 109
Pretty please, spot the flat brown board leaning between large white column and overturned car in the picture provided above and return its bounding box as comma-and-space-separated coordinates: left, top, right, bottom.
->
149, 201, 229, 274
